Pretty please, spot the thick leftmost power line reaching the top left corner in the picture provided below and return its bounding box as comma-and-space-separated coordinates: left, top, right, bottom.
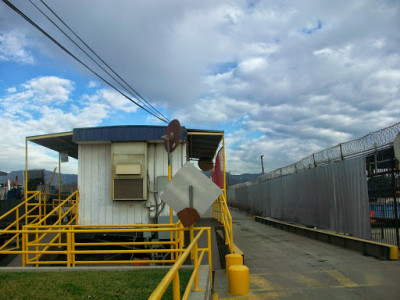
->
3, 0, 168, 123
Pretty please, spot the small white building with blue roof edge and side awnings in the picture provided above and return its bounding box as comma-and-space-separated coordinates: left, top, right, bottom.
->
26, 126, 223, 225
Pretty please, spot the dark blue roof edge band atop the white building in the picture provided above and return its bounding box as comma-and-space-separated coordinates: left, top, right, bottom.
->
72, 125, 186, 143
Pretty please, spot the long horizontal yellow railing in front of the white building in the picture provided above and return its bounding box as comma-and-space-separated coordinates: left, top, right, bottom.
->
2, 223, 212, 282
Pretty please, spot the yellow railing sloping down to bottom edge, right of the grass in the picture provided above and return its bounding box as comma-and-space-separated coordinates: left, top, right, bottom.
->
149, 227, 212, 300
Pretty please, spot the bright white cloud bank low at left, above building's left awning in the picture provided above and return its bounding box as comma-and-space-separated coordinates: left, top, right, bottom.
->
0, 76, 140, 172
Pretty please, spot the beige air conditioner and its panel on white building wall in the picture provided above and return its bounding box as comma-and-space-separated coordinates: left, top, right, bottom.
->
111, 142, 147, 200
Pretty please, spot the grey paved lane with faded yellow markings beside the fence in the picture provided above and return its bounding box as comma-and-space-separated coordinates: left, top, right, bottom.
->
214, 209, 400, 299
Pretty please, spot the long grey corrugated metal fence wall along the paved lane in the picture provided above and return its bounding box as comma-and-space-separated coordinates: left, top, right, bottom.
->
228, 157, 371, 239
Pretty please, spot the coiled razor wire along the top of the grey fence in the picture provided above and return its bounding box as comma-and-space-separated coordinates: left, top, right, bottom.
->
236, 122, 400, 187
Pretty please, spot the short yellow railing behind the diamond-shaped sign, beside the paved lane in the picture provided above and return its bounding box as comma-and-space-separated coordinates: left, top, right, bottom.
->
213, 193, 233, 253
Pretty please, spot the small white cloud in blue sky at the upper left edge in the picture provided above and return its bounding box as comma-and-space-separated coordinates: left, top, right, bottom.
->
0, 30, 34, 64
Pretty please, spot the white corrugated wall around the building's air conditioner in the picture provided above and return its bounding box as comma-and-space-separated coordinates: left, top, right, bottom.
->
78, 143, 186, 225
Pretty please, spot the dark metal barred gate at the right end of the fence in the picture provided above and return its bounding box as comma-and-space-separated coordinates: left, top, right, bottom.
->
366, 147, 400, 246
